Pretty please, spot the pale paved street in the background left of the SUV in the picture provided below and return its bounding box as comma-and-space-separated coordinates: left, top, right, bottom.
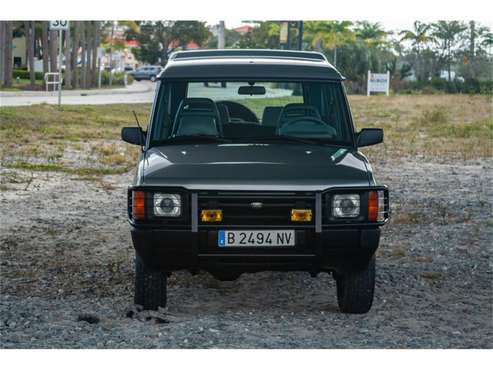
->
0, 81, 155, 107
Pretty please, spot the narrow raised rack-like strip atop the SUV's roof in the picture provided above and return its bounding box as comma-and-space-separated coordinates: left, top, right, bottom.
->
169, 49, 327, 62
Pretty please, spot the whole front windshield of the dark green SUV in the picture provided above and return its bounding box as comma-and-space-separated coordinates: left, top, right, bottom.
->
150, 81, 352, 146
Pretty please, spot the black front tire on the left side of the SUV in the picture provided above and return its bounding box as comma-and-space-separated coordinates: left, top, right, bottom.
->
134, 256, 167, 310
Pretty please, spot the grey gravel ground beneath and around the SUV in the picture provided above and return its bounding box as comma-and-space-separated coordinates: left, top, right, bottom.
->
0, 159, 493, 348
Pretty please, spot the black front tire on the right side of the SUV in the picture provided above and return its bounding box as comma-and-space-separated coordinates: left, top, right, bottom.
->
336, 256, 376, 314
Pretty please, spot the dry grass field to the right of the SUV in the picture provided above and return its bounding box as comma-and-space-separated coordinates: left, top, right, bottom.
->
349, 94, 493, 160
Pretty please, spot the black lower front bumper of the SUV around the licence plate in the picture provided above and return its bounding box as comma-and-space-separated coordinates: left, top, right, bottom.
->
131, 227, 380, 274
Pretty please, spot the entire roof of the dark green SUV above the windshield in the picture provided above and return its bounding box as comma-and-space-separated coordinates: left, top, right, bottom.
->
159, 49, 344, 81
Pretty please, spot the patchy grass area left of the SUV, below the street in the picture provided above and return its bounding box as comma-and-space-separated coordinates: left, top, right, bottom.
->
0, 104, 145, 177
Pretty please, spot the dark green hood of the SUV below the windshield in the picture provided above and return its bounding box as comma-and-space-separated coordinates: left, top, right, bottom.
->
142, 143, 369, 191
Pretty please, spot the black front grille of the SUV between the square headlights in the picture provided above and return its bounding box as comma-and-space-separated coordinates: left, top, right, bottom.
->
198, 192, 315, 226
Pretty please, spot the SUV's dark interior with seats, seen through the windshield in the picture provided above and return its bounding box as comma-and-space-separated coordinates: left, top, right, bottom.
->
152, 83, 348, 144
